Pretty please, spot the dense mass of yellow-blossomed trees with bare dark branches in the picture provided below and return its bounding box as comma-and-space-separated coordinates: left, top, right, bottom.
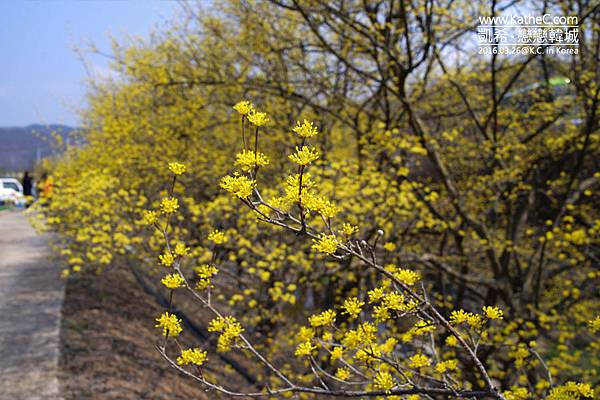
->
38, 1, 600, 399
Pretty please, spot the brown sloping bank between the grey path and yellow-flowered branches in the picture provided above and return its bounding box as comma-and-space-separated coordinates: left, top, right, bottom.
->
60, 268, 214, 400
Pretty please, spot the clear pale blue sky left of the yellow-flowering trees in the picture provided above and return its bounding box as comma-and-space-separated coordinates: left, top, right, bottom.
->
0, 0, 180, 126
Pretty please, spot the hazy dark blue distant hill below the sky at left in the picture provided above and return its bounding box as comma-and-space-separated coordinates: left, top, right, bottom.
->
0, 124, 77, 172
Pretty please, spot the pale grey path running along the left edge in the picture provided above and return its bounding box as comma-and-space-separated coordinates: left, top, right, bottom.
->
0, 211, 64, 400
